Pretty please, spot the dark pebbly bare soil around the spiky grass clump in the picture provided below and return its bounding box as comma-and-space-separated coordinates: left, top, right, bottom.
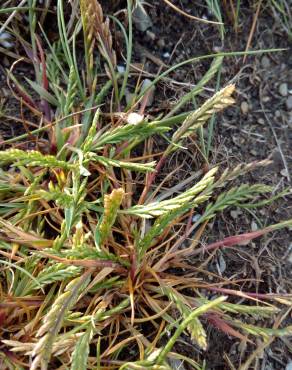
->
0, 0, 292, 370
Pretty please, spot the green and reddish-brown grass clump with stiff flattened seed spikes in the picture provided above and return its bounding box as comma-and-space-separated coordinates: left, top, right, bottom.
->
0, 0, 292, 370
